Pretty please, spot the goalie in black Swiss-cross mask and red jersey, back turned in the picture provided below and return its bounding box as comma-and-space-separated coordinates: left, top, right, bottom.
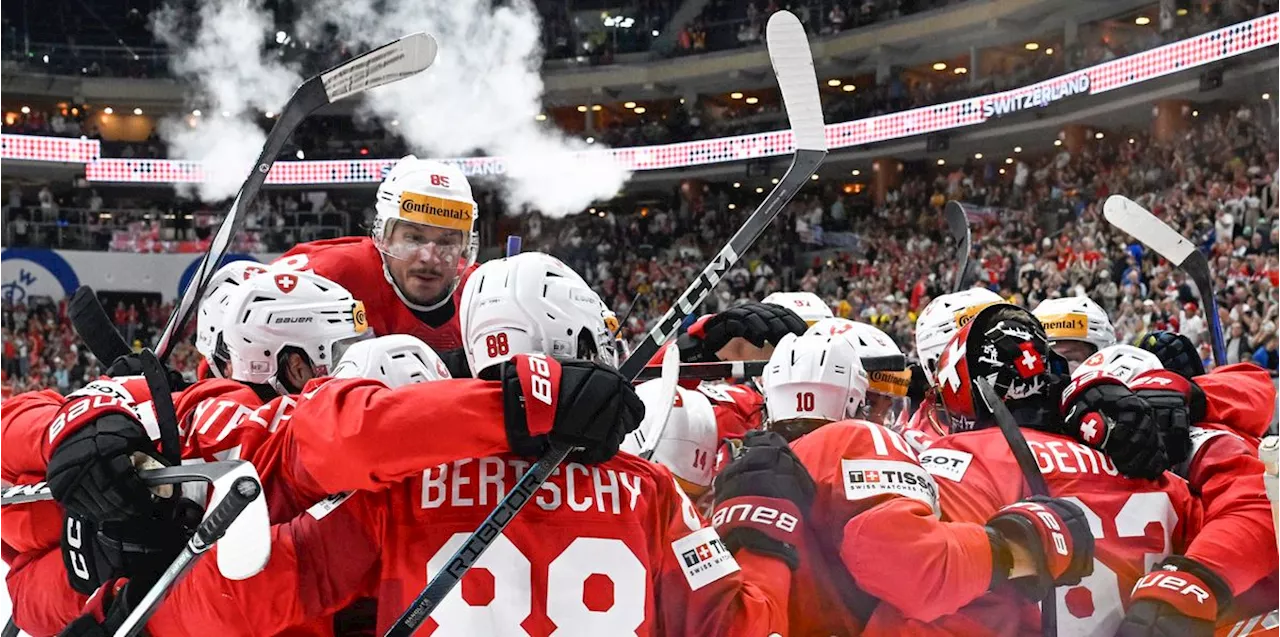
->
881, 303, 1198, 636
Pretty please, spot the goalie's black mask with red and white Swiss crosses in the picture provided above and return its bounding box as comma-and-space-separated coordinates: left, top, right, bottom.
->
937, 303, 1062, 434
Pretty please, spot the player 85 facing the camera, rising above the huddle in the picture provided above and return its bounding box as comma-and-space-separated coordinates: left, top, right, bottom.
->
273, 155, 479, 353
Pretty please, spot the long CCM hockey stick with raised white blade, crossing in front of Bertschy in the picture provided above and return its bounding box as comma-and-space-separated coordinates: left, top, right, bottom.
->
385, 12, 827, 637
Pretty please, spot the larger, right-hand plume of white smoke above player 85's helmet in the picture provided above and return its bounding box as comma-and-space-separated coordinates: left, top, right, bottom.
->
298, 0, 630, 215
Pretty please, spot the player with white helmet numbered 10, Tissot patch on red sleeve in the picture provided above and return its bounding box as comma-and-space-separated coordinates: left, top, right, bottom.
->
714, 334, 1092, 636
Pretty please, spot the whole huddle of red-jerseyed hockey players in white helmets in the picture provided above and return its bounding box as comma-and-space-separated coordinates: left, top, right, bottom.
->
0, 157, 1280, 637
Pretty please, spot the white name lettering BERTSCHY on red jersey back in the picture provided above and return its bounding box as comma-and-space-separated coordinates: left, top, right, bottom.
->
422, 457, 640, 515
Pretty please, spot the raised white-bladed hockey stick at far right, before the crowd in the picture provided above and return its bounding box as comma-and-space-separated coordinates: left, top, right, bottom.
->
1102, 194, 1226, 367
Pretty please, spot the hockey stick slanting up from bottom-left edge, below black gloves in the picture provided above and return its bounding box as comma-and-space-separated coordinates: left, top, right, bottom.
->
115, 473, 262, 637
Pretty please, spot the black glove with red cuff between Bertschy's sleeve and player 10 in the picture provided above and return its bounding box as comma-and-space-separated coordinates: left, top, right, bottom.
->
712, 431, 817, 570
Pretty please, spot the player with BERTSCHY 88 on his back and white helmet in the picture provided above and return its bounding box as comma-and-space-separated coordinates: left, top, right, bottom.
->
67, 253, 790, 637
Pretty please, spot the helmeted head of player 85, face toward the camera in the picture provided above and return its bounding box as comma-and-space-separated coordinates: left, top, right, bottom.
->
371, 155, 476, 311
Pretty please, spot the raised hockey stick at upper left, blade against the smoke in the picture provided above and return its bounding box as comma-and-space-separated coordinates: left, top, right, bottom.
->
156, 33, 436, 361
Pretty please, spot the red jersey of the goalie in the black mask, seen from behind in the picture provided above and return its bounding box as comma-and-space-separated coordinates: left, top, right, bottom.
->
901, 427, 1201, 636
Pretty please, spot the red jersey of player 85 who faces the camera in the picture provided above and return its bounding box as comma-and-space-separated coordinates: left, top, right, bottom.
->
273, 237, 476, 352
